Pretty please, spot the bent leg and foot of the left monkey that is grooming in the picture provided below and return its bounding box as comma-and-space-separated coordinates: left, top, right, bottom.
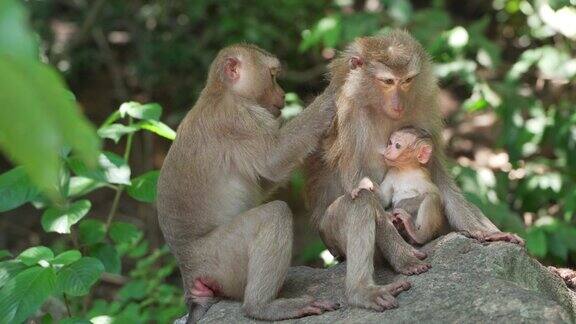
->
187, 201, 338, 321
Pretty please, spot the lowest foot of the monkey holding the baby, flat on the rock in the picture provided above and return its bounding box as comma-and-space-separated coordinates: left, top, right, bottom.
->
348, 281, 410, 312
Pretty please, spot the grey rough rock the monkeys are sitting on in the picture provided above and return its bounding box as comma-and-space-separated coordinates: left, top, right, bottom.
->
194, 233, 576, 323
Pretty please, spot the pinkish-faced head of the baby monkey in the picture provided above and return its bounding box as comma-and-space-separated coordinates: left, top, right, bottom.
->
384, 126, 433, 168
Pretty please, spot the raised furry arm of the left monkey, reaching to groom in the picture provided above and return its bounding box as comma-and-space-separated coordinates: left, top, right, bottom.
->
266, 94, 336, 181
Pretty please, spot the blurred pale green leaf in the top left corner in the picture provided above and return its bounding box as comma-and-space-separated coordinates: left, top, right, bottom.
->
0, 0, 38, 60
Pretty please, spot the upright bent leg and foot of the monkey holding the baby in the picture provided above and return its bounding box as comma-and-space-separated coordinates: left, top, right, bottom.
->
319, 190, 410, 311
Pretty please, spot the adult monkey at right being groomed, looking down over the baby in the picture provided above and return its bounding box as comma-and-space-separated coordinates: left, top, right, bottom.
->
306, 30, 523, 310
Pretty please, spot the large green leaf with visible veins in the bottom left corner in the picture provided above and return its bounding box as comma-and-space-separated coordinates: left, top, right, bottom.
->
0, 267, 56, 323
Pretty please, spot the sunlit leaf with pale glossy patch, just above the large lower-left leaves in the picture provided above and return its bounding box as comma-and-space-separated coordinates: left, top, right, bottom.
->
42, 199, 92, 234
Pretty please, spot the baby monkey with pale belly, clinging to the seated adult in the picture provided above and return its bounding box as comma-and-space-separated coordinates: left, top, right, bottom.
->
352, 126, 448, 244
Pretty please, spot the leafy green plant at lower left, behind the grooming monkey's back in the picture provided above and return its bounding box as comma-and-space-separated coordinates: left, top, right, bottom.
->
0, 95, 178, 323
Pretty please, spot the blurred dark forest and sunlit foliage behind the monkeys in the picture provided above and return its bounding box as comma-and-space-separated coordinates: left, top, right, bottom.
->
0, 0, 576, 323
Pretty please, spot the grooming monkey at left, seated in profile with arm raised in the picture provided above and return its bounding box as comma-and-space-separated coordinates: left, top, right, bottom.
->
158, 44, 338, 322
